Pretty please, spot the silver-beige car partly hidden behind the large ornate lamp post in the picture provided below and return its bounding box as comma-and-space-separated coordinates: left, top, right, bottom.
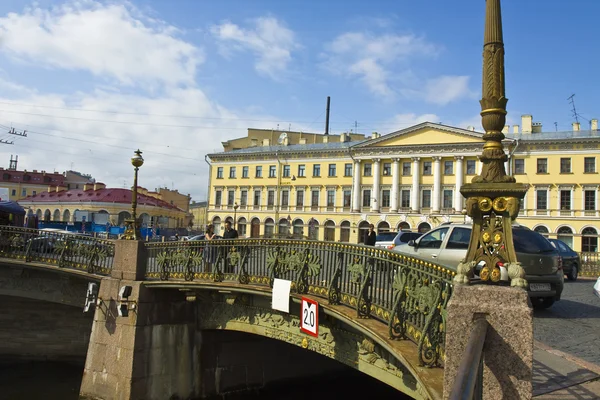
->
394, 224, 564, 308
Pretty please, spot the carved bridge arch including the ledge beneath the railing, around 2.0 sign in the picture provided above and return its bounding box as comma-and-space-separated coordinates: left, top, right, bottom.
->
145, 282, 436, 399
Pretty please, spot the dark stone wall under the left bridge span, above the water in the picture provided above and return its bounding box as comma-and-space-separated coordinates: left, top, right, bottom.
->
0, 295, 93, 364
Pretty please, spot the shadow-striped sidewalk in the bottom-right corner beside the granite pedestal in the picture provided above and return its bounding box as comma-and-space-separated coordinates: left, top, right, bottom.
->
533, 341, 600, 400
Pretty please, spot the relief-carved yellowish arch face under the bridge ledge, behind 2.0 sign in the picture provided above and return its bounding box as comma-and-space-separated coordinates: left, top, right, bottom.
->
197, 292, 434, 399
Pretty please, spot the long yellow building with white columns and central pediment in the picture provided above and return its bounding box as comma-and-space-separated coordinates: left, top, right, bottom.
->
207, 115, 600, 251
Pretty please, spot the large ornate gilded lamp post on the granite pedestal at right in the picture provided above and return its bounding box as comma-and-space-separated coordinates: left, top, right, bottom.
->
454, 0, 527, 287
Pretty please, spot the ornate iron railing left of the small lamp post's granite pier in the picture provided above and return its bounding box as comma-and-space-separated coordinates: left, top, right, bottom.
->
0, 226, 115, 275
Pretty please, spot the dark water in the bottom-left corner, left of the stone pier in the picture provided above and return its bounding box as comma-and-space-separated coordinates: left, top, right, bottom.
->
0, 362, 83, 400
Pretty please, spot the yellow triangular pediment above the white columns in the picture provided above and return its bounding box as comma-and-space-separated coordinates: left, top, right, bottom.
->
356, 122, 484, 148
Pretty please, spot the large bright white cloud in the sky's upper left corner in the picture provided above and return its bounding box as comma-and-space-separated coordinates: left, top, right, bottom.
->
0, 0, 203, 84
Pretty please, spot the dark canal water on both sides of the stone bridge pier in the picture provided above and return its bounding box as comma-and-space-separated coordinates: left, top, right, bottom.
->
0, 362, 410, 400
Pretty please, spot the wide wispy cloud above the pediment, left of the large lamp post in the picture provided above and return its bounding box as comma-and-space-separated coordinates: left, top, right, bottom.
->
323, 32, 438, 97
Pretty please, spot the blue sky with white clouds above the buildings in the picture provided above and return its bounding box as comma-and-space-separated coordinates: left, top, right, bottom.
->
0, 0, 600, 201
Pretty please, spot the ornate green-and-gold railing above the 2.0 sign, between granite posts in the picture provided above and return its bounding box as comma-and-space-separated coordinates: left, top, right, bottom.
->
146, 239, 454, 367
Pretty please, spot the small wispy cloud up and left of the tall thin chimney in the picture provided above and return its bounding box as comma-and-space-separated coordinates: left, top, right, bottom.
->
210, 17, 299, 79
